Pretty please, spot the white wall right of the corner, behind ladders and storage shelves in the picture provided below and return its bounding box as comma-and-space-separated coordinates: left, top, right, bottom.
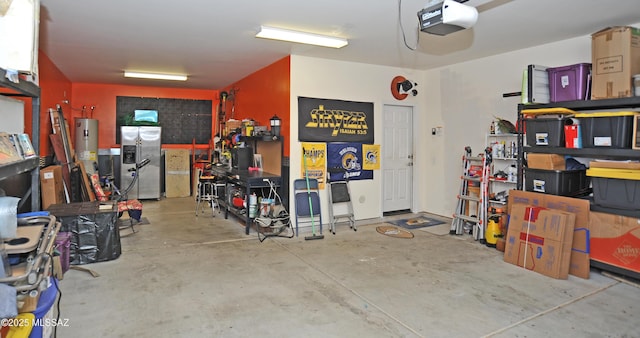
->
418, 36, 591, 216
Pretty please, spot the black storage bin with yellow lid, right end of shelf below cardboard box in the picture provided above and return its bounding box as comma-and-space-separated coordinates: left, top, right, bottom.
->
576, 112, 634, 148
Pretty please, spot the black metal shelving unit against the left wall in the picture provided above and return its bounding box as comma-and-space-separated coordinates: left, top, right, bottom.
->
0, 68, 40, 211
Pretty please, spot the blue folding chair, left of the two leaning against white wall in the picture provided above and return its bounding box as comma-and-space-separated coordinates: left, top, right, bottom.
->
293, 178, 322, 236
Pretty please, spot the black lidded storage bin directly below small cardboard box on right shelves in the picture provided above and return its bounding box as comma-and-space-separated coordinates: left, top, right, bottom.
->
525, 168, 590, 196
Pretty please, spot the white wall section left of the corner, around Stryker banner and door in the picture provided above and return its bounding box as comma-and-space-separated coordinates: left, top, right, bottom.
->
289, 55, 430, 224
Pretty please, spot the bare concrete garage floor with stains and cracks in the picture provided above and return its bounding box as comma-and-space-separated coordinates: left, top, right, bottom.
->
57, 198, 640, 337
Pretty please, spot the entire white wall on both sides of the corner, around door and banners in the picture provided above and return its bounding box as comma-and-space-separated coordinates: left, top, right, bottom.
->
290, 25, 637, 224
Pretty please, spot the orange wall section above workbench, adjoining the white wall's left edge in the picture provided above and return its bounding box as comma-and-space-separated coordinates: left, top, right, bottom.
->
223, 56, 291, 156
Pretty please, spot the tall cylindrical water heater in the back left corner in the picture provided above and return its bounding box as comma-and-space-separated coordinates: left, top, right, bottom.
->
75, 118, 98, 175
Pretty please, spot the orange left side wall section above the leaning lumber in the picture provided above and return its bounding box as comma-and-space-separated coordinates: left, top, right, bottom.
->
24, 52, 71, 156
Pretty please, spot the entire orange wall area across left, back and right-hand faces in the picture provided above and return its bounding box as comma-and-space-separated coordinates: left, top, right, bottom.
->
32, 53, 290, 156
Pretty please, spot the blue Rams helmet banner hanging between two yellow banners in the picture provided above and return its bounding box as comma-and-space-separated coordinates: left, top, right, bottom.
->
327, 143, 373, 181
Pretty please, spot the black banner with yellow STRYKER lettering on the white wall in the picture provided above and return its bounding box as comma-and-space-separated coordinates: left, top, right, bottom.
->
298, 97, 373, 144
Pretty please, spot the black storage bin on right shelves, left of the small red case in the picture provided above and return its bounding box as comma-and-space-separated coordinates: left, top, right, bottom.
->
524, 117, 565, 147
